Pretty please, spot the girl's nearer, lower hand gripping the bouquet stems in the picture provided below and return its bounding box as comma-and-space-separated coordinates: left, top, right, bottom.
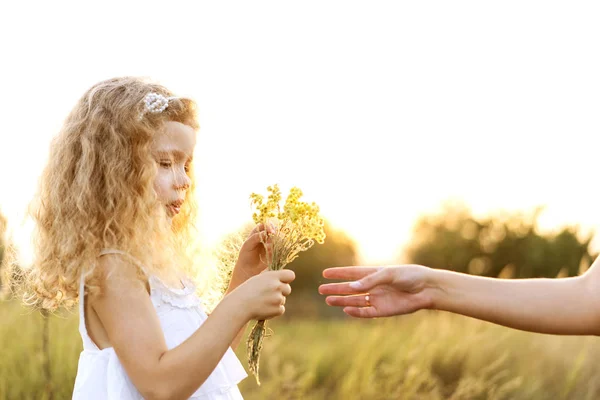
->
230, 269, 296, 320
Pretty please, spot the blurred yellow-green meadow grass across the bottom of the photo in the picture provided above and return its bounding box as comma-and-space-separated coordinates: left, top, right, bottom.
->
0, 302, 600, 400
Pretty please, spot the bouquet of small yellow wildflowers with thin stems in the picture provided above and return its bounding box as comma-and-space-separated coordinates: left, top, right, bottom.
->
247, 185, 325, 385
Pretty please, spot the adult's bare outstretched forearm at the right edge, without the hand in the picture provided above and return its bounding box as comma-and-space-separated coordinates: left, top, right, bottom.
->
431, 270, 600, 335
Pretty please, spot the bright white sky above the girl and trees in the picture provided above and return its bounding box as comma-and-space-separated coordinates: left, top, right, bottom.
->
0, 0, 600, 264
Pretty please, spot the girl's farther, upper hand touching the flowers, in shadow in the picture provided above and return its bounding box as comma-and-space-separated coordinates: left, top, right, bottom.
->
235, 223, 275, 278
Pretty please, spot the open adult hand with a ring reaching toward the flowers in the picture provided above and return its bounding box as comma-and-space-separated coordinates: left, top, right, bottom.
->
319, 265, 433, 318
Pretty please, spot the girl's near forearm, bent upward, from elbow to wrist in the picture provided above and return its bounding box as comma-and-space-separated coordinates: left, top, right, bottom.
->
154, 296, 248, 398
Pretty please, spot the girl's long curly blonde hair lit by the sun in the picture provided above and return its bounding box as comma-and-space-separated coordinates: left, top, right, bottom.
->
26, 77, 199, 310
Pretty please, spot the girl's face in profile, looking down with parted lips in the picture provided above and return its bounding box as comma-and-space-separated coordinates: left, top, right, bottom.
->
152, 121, 196, 219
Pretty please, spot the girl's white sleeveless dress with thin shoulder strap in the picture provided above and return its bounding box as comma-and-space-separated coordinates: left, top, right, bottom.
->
73, 249, 248, 400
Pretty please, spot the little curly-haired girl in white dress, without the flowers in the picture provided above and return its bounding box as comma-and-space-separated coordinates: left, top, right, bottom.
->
29, 78, 294, 400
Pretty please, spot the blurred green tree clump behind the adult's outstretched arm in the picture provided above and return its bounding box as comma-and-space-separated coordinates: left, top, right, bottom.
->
406, 203, 595, 278
